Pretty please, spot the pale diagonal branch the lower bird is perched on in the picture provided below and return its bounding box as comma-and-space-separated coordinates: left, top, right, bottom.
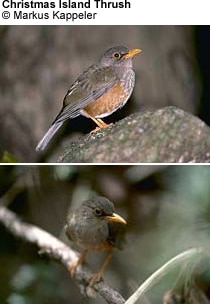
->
0, 206, 125, 304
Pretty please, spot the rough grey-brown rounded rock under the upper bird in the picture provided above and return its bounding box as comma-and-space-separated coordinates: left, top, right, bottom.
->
58, 106, 210, 163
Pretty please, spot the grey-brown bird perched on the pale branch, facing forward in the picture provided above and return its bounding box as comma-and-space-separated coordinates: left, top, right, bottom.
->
64, 196, 126, 286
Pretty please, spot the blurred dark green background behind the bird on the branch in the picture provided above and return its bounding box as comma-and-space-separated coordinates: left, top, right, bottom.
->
0, 165, 210, 303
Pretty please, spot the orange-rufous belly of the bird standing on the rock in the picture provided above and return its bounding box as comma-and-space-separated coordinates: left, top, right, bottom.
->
81, 84, 130, 118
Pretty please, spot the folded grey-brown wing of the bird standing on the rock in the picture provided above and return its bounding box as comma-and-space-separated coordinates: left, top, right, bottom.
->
53, 65, 118, 124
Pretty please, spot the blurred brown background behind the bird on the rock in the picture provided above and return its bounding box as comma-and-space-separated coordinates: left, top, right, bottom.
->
0, 26, 210, 162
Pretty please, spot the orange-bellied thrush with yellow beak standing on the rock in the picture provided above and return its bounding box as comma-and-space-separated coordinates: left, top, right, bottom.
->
36, 46, 142, 151
